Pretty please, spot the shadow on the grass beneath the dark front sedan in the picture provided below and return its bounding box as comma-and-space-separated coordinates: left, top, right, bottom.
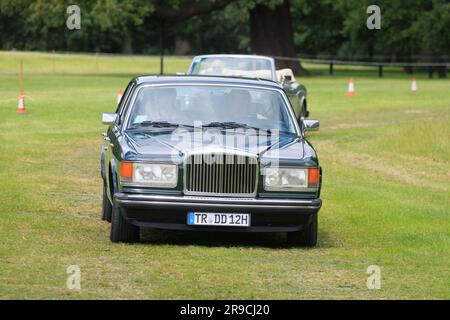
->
141, 229, 341, 249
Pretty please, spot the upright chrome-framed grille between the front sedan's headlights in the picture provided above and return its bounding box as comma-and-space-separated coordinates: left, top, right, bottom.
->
184, 153, 258, 197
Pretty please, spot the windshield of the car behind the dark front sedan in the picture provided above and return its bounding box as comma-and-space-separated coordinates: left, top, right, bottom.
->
191, 57, 273, 80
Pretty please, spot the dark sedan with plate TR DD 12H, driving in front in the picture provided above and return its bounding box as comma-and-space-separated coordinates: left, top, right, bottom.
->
101, 76, 322, 246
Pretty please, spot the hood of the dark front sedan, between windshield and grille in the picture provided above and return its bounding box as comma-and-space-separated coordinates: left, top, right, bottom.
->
119, 130, 315, 165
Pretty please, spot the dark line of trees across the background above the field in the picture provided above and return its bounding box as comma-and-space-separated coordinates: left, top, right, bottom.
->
0, 0, 450, 72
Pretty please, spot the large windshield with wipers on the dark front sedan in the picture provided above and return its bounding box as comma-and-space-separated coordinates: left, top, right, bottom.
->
127, 85, 296, 134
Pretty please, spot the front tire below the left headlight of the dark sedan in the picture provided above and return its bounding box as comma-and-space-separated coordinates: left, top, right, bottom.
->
110, 204, 139, 243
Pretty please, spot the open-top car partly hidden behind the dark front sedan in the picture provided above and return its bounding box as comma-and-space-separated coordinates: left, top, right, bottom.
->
187, 54, 309, 118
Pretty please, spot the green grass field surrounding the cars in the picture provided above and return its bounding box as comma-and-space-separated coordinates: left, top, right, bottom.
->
0, 53, 450, 299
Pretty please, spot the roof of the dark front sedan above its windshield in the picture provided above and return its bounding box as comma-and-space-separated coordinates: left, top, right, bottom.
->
134, 75, 283, 89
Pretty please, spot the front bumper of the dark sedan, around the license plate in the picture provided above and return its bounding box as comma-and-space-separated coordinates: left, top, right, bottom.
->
114, 193, 322, 232
